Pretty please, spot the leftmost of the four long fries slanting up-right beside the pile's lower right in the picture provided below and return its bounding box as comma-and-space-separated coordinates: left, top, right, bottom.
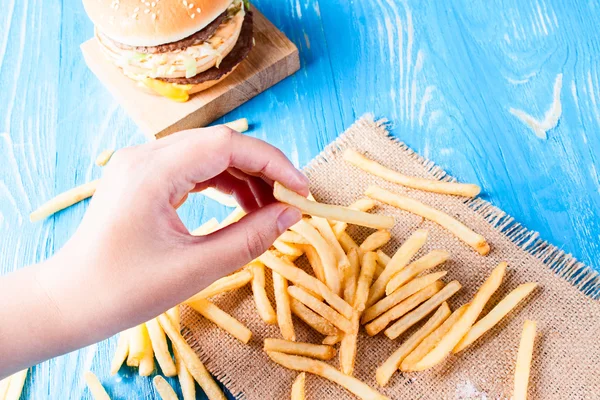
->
375, 302, 450, 386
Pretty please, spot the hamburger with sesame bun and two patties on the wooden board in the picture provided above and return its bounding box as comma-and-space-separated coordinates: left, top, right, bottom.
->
83, 0, 254, 102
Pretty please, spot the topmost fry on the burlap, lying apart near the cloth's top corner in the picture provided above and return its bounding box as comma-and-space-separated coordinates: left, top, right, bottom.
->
344, 149, 481, 197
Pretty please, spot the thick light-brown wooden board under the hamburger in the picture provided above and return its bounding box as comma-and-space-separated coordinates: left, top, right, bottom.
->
81, 8, 300, 139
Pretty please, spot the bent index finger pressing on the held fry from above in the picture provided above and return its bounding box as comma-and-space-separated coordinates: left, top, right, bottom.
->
157, 125, 308, 196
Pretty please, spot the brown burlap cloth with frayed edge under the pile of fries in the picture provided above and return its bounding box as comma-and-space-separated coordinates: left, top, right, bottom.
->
182, 116, 600, 400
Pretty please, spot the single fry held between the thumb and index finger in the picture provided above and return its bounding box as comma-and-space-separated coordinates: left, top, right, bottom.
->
273, 182, 394, 229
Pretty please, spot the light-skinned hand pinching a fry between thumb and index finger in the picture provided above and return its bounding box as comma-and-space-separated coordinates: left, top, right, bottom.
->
0, 126, 308, 368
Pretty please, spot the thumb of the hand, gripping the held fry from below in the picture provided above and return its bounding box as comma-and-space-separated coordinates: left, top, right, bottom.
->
185, 202, 302, 283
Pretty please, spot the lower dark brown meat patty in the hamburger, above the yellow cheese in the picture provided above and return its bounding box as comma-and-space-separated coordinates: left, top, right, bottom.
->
156, 11, 254, 85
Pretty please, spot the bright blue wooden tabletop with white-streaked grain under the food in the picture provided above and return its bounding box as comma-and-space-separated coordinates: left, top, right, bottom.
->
0, 0, 600, 399
